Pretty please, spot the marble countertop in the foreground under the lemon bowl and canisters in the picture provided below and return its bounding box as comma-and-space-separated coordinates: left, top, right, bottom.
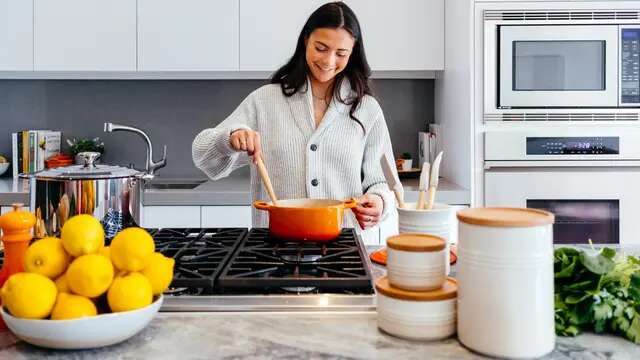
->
0, 313, 640, 360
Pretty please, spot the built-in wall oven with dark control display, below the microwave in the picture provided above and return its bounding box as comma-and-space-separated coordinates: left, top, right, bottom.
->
484, 126, 640, 244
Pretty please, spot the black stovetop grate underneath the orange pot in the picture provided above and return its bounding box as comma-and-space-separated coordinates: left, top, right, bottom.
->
218, 228, 373, 293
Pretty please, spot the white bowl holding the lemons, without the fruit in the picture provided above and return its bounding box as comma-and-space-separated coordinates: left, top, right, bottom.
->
0, 295, 163, 349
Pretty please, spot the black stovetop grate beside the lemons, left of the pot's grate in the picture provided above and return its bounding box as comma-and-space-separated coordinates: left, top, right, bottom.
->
147, 228, 248, 290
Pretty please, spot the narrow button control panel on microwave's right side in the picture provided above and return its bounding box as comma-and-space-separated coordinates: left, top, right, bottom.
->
620, 28, 640, 105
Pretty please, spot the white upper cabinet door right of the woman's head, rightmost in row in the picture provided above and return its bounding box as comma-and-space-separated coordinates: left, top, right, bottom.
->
345, 0, 445, 71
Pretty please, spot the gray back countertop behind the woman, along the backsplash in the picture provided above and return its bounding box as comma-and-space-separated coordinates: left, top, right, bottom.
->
0, 171, 471, 206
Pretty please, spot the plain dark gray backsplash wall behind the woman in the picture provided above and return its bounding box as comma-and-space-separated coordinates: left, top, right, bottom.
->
0, 80, 434, 177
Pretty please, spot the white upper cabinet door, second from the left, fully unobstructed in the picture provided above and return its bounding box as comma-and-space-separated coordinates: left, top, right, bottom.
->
138, 0, 240, 71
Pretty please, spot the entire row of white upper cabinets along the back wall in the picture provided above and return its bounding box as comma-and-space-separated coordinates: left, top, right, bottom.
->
0, 0, 445, 78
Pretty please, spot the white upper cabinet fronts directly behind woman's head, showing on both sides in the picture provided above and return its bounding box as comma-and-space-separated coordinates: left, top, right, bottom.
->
240, 0, 444, 71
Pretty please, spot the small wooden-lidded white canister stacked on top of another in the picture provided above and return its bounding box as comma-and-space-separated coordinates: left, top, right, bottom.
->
387, 233, 447, 291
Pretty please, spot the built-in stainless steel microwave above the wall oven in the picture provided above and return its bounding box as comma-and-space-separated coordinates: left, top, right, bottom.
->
484, 14, 640, 113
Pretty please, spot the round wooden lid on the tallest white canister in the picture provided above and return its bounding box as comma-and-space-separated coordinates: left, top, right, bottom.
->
457, 208, 554, 227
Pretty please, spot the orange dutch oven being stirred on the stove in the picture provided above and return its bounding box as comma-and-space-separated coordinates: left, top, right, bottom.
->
253, 199, 358, 242
